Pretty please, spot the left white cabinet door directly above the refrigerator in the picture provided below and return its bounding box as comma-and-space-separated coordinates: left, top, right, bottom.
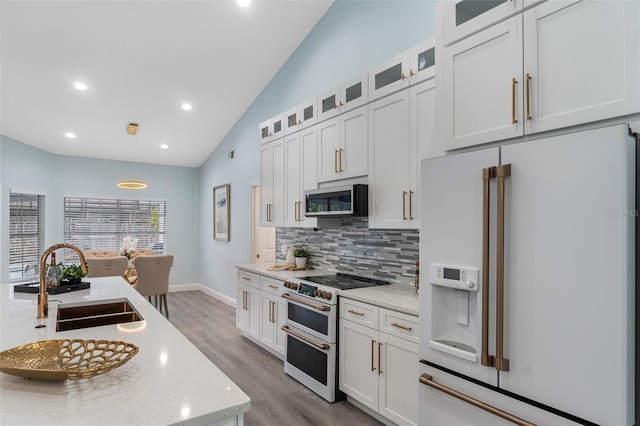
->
437, 16, 524, 150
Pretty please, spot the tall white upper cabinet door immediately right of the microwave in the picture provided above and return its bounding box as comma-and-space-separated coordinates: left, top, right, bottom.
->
368, 90, 417, 228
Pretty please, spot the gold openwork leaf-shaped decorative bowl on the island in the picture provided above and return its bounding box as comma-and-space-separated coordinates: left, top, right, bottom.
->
0, 339, 138, 380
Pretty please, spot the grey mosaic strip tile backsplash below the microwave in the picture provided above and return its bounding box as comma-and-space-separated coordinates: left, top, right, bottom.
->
276, 217, 419, 286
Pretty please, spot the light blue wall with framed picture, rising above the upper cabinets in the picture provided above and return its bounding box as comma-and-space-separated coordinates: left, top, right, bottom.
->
199, 0, 435, 299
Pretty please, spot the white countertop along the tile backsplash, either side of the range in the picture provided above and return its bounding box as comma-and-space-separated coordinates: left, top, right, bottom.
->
236, 263, 420, 316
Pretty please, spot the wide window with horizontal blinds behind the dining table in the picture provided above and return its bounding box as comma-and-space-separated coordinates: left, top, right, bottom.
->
64, 197, 166, 262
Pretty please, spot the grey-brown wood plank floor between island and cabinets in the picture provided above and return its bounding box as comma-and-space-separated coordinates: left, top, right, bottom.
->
168, 291, 381, 426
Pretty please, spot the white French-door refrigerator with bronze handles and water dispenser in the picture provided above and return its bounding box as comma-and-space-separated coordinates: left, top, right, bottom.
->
419, 125, 637, 426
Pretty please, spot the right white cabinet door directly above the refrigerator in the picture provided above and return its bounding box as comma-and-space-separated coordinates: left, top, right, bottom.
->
523, 1, 640, 133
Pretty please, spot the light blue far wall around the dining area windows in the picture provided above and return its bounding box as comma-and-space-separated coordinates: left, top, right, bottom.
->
0, 136, 200, 284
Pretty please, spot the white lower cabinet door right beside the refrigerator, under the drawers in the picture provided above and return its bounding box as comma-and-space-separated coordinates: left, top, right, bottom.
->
378, 333, 420, 425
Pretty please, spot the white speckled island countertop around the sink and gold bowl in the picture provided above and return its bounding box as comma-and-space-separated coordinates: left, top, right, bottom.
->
0, 277, 250, 425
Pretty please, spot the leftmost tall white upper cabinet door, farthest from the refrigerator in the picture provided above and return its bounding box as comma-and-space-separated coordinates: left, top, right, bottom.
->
260, 138, 285, 226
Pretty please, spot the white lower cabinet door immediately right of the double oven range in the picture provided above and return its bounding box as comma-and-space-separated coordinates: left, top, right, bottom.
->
339, 319, 379, 411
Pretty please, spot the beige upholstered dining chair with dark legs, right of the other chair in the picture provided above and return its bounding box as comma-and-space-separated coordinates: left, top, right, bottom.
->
133, 254, 173, 318
